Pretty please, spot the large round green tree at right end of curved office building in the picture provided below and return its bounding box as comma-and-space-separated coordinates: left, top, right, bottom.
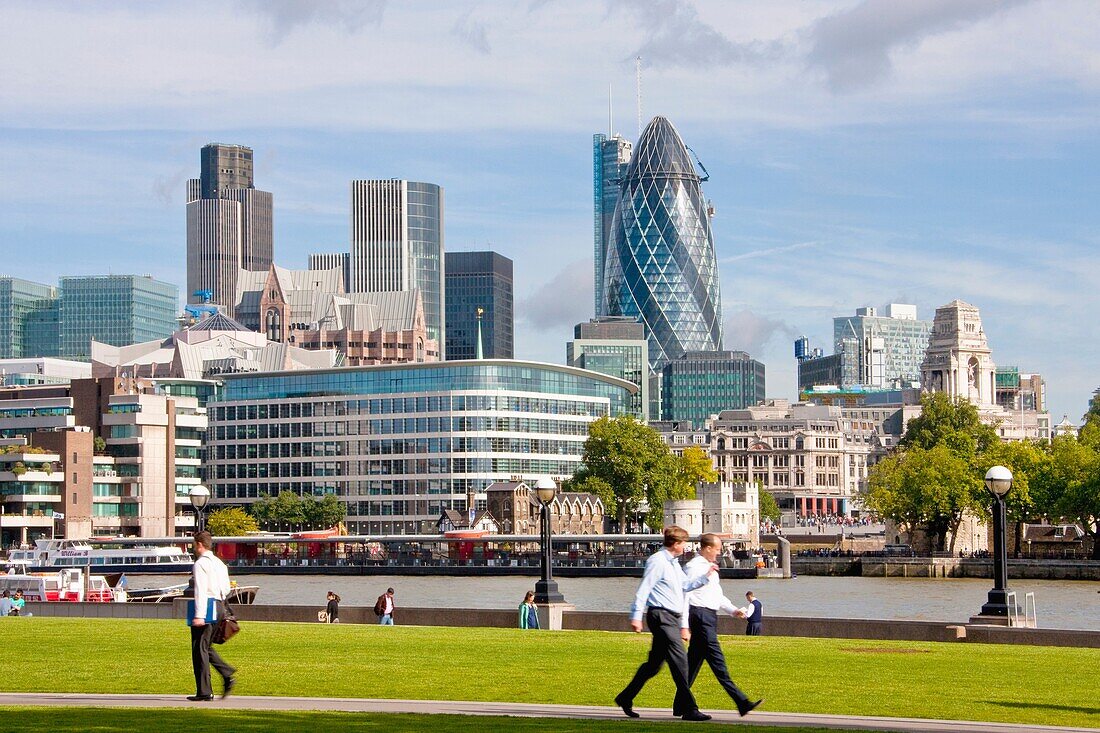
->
568, 416, 686, 529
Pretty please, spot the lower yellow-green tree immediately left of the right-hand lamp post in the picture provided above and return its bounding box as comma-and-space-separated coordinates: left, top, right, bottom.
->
864, 445, 982, 551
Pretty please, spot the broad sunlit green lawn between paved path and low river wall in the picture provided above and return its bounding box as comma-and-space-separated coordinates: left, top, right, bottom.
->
0, 617, 1100, 727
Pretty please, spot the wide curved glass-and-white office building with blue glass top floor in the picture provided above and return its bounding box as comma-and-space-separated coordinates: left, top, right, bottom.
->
206, 359, 638, 534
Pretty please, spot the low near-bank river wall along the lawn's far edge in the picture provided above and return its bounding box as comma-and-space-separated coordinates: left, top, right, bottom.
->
26, 600, 1100, 648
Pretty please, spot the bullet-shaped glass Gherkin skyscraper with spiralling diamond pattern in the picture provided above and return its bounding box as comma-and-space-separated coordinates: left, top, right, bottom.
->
604, 117, 722, 369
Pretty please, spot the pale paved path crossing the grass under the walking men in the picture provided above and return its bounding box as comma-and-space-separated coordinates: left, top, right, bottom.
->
0, 692, 1100, 733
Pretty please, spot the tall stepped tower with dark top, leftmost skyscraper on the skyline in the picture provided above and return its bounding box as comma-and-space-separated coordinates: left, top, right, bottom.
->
187, 143, 274, 316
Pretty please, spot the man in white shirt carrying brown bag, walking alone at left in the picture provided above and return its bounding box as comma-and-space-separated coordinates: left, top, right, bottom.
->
187, 530, 237, 702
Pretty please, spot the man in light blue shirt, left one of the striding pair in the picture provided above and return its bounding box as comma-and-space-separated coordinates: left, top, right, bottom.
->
615, 525, 718, 721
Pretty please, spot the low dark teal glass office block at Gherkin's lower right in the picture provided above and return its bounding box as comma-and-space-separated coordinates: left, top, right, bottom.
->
661, 351, 765, 428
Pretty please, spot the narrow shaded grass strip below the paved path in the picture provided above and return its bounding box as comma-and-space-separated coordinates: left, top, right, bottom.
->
0, 708, 866, 733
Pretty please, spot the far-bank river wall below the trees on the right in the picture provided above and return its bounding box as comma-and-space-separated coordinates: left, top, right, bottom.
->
792, 557, 1100, 580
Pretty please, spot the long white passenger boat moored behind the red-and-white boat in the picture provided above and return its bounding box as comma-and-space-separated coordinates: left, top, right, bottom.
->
8, 539, 195, 575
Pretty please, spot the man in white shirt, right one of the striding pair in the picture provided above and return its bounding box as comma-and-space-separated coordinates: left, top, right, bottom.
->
672, 533, 763, 716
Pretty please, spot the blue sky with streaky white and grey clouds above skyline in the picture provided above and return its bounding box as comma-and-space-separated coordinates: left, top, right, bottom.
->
0, 0, 1100, 422
